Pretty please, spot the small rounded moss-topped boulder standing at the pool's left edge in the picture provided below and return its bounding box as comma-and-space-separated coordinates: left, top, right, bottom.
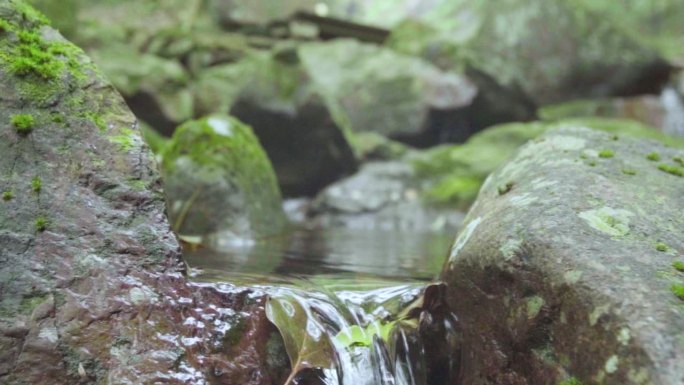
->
161, 115, 285, 239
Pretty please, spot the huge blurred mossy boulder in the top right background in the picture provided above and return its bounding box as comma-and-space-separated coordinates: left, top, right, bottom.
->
389, 0, 672, 105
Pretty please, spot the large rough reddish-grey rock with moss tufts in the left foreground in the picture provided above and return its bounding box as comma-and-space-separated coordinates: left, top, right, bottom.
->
0, 0, 287, 385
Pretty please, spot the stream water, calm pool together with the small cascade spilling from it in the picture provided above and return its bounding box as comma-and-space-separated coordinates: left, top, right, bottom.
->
185, 228, 460, 385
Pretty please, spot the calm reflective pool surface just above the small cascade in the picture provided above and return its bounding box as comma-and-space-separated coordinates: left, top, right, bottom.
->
185, 228, 452, 282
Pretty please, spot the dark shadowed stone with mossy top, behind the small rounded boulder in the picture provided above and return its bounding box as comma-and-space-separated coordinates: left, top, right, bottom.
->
230, 47, 357, 197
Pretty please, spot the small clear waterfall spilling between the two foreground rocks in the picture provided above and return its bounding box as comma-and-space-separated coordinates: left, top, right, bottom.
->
267, 284, 460, 385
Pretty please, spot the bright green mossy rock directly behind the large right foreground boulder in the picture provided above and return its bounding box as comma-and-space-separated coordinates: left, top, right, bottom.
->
413, 118, 684, 208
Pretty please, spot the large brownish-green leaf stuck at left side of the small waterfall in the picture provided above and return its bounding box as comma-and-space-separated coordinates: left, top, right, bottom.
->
266, 297, 334, 384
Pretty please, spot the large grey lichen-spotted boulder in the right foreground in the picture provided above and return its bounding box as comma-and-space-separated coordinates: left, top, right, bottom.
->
442, 124, 684, 385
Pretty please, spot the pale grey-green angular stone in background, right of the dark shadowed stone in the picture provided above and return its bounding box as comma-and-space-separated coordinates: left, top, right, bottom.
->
298, 39, 477, 142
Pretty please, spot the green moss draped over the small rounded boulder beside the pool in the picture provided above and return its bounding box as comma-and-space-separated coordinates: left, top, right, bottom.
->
160, 115, 284, 235
